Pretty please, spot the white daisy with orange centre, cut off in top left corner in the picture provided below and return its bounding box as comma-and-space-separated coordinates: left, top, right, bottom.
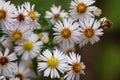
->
0, 0, 16, 27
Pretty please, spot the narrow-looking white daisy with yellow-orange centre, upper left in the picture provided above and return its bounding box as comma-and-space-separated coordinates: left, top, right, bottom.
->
23, 2, 40, 29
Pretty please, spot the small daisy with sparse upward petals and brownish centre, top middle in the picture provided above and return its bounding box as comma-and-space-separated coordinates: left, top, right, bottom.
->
45, 5, 68, 24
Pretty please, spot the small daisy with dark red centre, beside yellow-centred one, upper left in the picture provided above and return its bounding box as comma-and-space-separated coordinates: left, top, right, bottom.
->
15, 5, 31, 24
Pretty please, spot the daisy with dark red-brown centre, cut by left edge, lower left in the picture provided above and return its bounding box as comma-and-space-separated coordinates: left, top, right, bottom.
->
0, 48, 17, 75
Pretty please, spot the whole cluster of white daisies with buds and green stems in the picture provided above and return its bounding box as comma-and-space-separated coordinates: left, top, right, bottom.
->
0, 0, 112, 80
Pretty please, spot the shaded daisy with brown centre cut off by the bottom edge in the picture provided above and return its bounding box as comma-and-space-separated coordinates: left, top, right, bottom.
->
7, 61, 32, 80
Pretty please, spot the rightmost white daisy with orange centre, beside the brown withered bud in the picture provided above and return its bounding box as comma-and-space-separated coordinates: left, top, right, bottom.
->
79, 18, 103, 47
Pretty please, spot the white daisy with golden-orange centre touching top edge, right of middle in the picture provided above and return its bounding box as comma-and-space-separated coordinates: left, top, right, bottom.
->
69, 0, 96, 19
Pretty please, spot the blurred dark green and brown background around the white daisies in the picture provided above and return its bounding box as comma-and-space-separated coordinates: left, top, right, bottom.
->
12, 0, 120, 80
